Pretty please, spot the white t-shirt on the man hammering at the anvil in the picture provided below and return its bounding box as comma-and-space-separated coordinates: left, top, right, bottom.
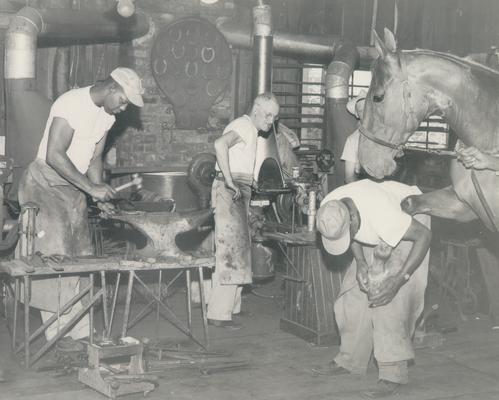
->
37, 86, 116, 174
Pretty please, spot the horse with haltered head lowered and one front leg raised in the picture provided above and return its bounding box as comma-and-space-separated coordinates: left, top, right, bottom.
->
359, 28, 499, 232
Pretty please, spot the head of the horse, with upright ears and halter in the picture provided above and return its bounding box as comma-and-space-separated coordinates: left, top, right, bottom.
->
359, 28, 428, 179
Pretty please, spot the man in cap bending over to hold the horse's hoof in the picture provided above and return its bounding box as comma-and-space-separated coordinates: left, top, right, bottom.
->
314, 179, 431, 398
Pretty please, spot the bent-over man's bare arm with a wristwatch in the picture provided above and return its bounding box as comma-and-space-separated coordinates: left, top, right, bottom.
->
369, 218, 431, 307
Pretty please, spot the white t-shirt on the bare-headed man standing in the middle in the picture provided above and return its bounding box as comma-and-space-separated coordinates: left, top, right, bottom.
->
216, 115, 258, 176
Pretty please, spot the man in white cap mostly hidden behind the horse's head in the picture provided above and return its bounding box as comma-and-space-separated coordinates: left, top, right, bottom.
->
341, 89, 367, 183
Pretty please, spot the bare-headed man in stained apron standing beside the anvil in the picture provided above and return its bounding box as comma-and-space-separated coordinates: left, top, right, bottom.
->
208, 93, 279, 327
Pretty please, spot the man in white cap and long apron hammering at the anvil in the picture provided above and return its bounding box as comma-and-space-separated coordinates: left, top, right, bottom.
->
19, 67, 144, 342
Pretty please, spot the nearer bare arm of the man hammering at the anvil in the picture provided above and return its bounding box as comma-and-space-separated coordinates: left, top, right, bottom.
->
46, 117, 114, 201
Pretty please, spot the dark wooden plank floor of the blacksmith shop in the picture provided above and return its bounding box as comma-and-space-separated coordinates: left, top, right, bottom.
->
0, 280, 499, 400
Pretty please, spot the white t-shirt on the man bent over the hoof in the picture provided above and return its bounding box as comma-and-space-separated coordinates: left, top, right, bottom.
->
321, 179, 421, 247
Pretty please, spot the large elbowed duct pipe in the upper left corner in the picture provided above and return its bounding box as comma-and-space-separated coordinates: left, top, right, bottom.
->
0, 7, 149, 199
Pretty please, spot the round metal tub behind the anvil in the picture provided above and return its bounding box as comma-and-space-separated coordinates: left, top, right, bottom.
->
142, 172, 199, 212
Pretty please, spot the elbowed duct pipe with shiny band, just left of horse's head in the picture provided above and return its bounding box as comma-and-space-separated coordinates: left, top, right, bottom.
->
323, 42, 359, 191
